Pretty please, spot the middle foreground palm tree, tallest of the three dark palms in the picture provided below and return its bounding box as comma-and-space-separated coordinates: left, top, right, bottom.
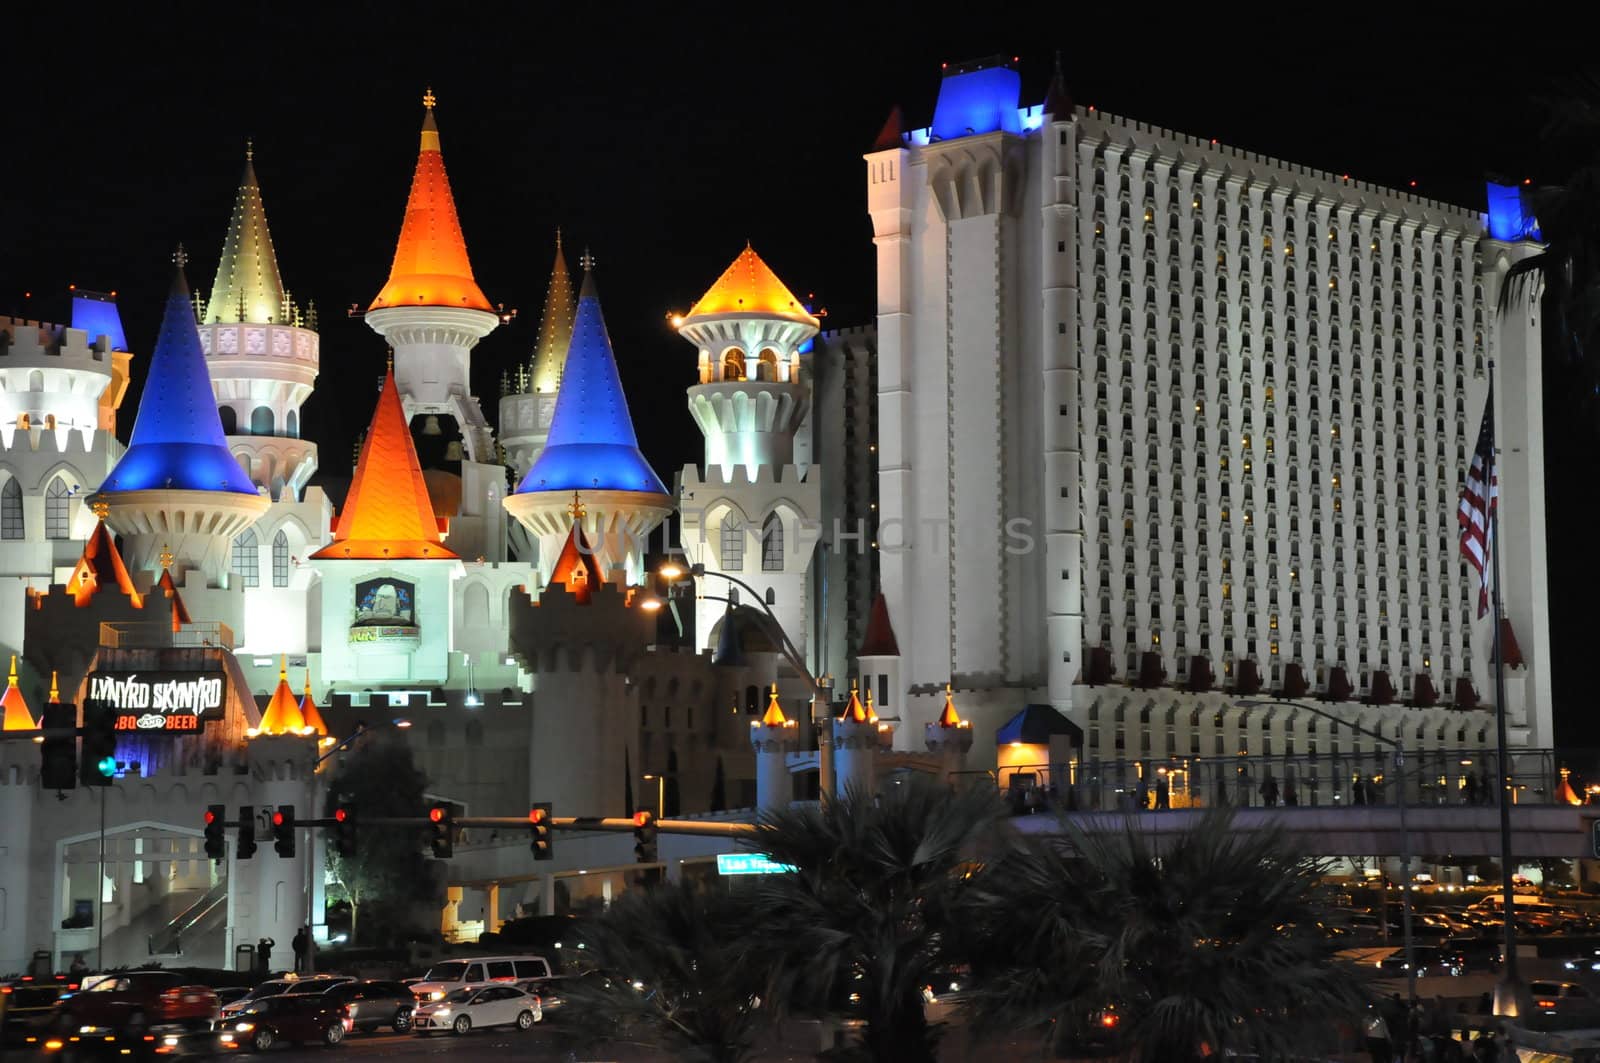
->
750, 776, 1002, 1063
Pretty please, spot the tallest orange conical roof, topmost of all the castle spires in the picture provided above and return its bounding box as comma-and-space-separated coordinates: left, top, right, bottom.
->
368, 90, 494, 312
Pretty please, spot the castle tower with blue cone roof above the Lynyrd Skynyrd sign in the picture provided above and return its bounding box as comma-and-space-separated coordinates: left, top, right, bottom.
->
94, 257, 270, 589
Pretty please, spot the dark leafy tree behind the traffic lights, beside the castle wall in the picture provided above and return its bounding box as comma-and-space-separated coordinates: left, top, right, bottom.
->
326, 736, 434, 941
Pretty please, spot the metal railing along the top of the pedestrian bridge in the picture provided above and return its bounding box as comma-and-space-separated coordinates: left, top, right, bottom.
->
957, 749, 1573, 812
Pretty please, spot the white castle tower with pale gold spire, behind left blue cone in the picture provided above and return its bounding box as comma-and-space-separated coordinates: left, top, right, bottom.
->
200, 147, 320, 501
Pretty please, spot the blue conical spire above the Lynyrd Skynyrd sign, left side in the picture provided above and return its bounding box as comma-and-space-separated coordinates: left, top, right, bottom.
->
101, 256, 256, 495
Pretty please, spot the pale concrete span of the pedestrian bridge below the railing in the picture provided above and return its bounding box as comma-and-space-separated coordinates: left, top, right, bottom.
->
1010, 805, 1600, 860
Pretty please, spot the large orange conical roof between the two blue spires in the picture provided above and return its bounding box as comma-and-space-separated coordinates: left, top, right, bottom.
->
312, 368, 454, 560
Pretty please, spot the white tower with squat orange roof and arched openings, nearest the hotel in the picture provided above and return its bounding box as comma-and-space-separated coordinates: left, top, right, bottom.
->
674, 245, 822, 665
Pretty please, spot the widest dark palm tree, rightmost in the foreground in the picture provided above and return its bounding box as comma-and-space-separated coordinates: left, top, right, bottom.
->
966, 812, 1366, 1063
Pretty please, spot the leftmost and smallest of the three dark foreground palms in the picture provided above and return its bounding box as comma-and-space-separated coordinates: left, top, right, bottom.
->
562, 880, 760, 1063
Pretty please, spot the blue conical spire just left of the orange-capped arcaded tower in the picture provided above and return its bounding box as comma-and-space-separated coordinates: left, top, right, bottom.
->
517, 251, 667, 495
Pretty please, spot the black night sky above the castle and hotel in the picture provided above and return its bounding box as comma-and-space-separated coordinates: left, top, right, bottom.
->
0, 3, 1600, 746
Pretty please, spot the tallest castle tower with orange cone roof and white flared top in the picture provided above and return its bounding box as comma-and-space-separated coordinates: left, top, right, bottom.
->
366, 91, 506, 560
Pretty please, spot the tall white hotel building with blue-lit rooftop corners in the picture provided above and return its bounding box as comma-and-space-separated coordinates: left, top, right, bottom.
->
866, 61, 1552, 760
